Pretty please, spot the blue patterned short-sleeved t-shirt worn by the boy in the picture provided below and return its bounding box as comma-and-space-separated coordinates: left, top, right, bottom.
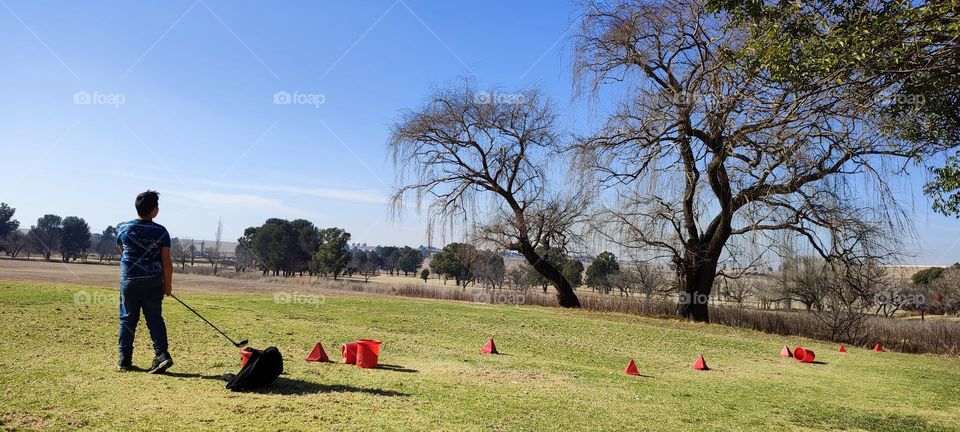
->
117, 219, 170, 280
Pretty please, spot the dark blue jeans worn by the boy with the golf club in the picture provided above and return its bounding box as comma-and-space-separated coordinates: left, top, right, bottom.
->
119, 277, 167, 360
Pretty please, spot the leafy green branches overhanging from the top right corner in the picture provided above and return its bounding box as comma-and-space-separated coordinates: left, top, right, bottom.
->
707, 0, 960, 216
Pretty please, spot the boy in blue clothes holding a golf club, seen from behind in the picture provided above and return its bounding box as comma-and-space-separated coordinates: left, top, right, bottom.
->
117, 190, 173, 374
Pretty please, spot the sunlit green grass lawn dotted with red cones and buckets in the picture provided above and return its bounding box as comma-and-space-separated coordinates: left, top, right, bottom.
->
0, 282, 960, 431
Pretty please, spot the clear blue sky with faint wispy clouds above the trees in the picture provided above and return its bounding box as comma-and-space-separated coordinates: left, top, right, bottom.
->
0, 0, 960, 263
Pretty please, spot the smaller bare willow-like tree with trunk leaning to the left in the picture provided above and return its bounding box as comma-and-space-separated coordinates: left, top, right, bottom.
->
389, 80, 587, 307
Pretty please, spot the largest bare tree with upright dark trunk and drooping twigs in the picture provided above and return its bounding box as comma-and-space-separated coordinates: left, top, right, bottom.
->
574, 0, 916, 321
